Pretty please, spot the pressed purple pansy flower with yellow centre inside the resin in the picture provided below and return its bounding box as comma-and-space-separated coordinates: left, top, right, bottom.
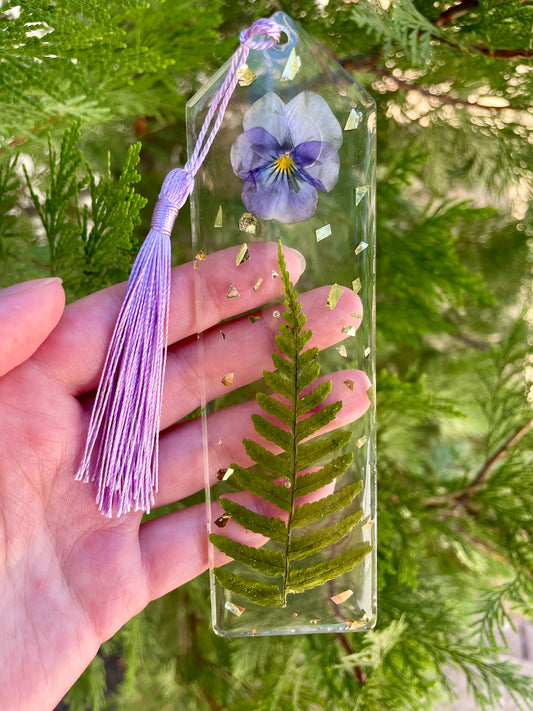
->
231, 91, 342, 224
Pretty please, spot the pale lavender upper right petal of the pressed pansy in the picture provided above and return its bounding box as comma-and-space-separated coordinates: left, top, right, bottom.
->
286, 91, 342, 150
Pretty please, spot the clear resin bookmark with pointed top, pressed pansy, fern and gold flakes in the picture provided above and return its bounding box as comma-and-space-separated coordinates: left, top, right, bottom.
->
187, 12, 376, 636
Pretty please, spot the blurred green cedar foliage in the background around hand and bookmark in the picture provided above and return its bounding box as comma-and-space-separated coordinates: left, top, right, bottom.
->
0, 0, 533, 711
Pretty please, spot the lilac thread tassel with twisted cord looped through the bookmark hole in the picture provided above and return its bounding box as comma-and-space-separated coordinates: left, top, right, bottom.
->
76, 19, 281, 517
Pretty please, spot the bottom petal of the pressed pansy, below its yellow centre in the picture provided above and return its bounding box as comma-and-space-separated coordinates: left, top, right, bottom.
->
242, 180, 318, 224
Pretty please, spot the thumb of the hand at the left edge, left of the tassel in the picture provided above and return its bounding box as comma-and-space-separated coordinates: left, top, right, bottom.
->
0, 278, 65, 375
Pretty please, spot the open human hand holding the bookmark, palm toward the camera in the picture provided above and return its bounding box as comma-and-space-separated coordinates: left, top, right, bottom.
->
0, 244, 369, 711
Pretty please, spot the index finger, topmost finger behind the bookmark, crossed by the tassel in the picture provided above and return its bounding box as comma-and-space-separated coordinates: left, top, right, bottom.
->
34, 242, 305, 396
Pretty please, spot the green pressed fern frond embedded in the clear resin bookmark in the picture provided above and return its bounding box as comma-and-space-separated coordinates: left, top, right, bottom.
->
210, 242, 371, 607
